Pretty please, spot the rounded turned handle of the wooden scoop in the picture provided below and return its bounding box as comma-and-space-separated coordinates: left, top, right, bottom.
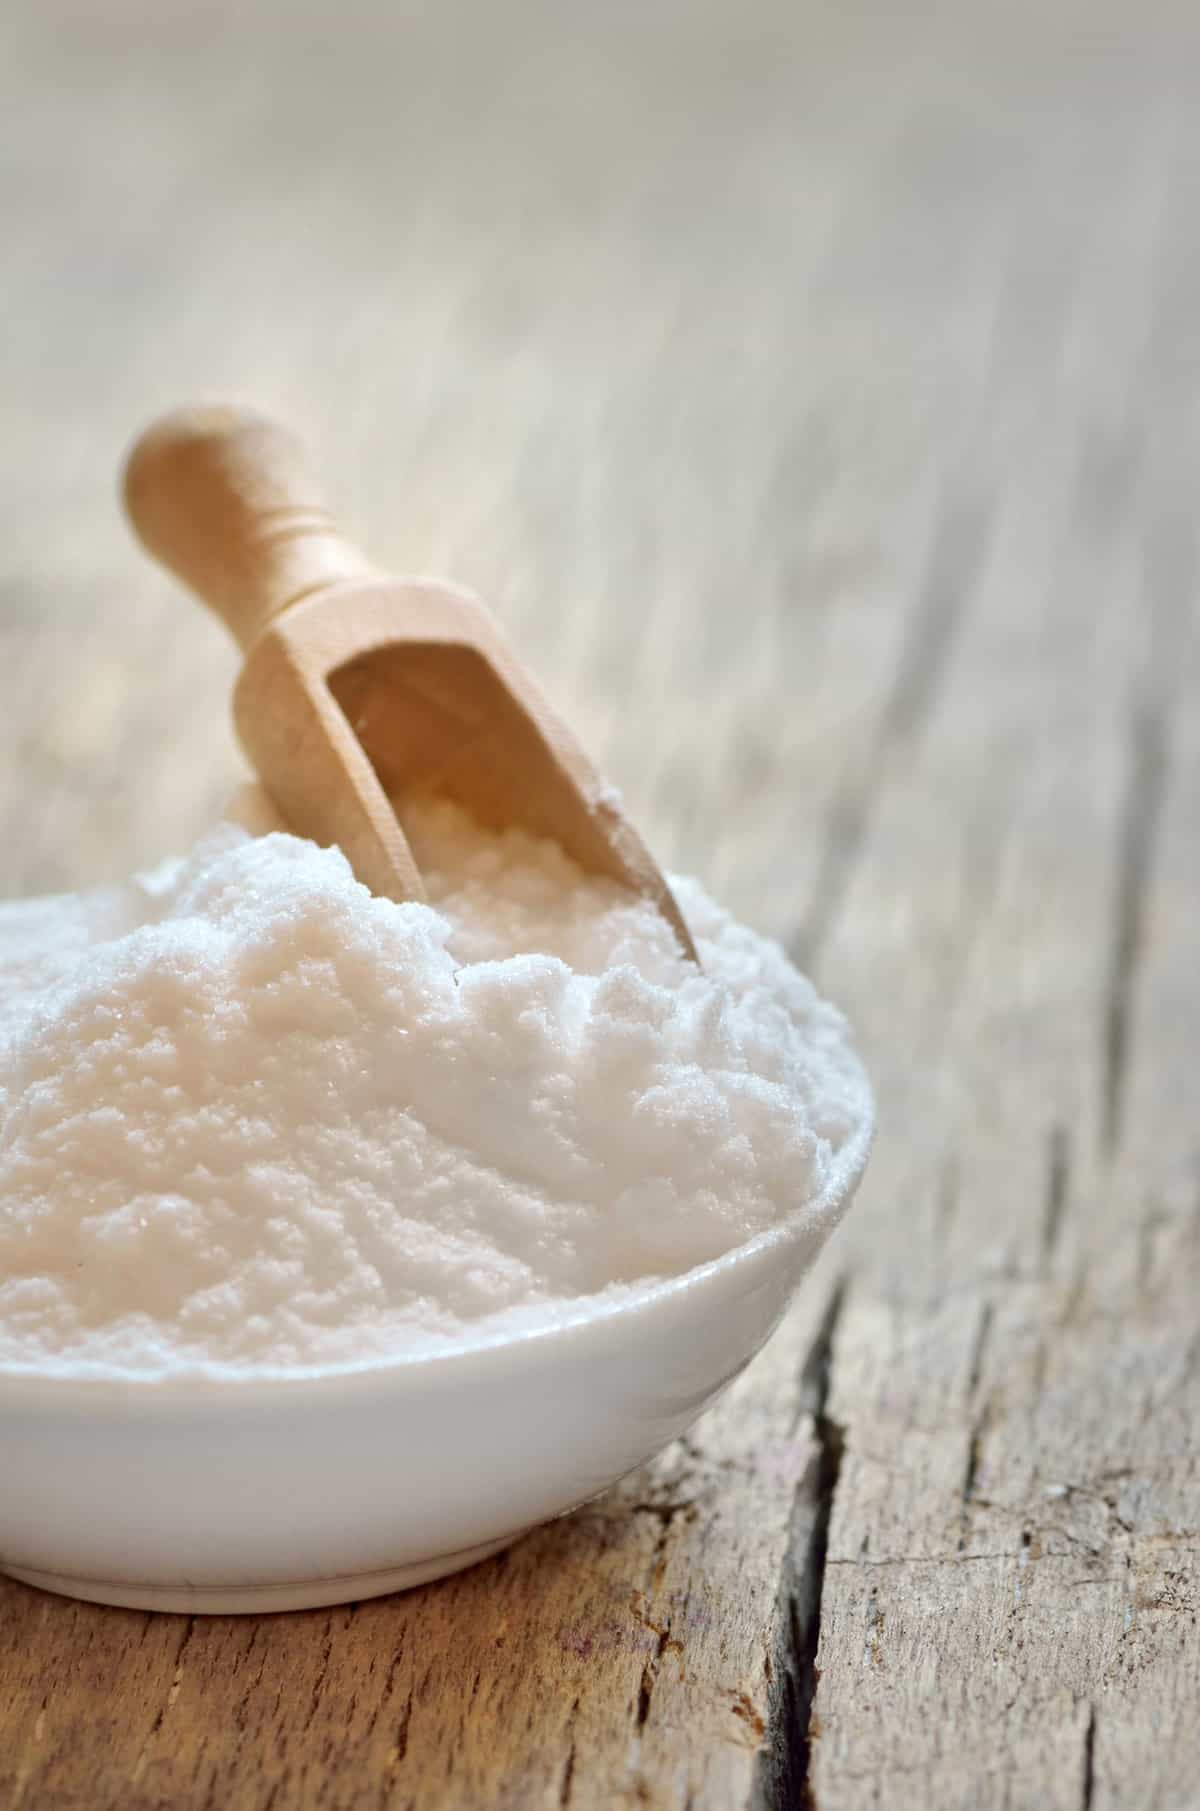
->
123, 402, 375, 648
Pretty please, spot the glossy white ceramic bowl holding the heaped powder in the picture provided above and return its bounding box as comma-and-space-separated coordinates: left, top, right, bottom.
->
0, 1126, 871, 1612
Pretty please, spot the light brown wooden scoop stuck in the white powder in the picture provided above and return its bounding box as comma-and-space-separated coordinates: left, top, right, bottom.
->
125, 404, 695, 960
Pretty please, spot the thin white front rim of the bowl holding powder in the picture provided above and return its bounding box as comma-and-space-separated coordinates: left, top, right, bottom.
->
0, 1056, 876, 1413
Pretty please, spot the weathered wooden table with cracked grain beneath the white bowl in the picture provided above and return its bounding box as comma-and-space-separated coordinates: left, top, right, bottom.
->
0, 0, 1200, 1811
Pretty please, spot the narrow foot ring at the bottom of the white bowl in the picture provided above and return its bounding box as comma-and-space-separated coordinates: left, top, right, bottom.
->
0, 1528, 525, 1615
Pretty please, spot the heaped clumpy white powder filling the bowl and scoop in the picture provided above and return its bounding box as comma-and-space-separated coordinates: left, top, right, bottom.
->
0, 806, 871, 1375
